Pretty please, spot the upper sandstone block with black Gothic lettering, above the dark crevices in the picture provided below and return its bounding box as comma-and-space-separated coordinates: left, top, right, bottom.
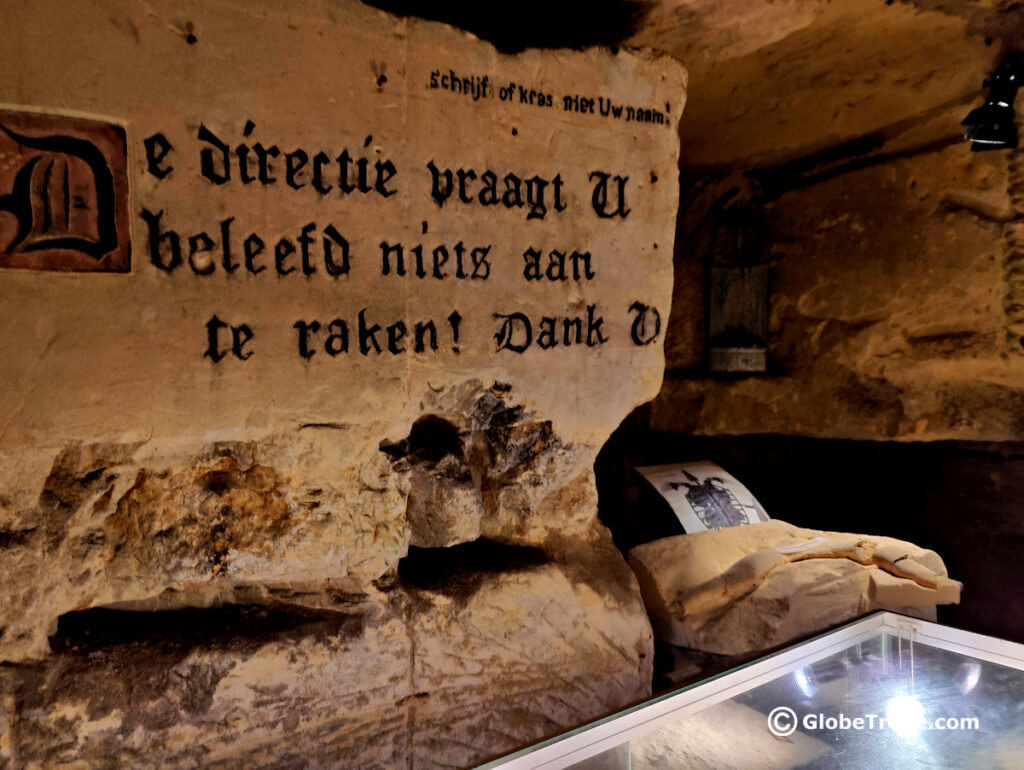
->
0, 0, 685, 660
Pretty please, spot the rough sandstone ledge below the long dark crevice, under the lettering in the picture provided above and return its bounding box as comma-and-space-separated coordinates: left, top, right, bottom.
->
0, 533, 652, 769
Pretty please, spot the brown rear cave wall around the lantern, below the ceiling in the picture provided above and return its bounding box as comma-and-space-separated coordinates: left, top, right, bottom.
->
651, 143, 1024, 441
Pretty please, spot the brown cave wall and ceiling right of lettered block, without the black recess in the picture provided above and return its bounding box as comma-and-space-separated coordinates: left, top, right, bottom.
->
632, 0, 1024, 441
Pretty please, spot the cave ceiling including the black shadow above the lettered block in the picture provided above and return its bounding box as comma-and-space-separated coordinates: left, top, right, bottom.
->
368, 0, 1024, 172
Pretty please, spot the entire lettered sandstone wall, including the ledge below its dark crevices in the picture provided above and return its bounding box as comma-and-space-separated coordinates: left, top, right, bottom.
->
0, 0, 686, 768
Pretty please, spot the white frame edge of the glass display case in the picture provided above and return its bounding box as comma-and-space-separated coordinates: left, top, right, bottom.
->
479, 611, 1024, 770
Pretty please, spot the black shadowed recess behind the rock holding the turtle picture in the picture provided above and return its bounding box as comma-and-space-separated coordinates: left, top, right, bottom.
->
596, 415, 1024, 643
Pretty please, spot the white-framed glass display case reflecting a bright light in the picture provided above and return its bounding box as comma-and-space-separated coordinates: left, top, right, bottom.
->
482, 612, 1024, 770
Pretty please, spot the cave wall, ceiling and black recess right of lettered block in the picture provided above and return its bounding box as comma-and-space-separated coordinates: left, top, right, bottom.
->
599, 0, 1024, 641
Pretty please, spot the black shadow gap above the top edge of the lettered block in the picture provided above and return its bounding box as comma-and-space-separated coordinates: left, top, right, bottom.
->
362, 0, 652, 53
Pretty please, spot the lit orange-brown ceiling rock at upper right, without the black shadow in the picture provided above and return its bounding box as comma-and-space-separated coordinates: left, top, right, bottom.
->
629, 0, 1007, 167
